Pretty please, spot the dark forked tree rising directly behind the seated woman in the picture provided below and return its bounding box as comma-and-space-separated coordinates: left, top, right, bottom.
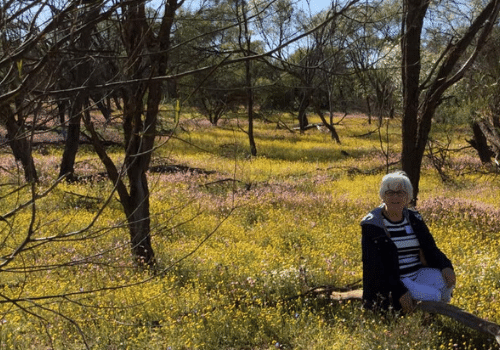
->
401, 0, 500, 201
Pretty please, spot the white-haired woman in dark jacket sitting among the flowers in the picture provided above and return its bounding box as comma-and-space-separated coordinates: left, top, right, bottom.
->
361, 172, 456, 313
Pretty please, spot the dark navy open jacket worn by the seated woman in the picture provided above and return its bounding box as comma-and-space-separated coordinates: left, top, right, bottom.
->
361, 206, 453, 310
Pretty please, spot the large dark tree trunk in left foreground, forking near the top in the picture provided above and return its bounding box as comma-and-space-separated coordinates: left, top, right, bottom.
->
112, 0, 179, 266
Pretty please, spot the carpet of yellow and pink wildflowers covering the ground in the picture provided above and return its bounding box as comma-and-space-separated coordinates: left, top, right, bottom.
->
0, 116, 500, 350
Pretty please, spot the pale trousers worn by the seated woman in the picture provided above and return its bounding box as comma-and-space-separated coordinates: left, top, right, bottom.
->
401, 267, 455, 303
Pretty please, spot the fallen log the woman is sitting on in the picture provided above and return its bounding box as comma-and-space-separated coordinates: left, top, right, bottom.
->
330, 289, 500, 344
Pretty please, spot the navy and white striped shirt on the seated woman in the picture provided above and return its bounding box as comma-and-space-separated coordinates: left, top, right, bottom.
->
384, 218, 423, 278
